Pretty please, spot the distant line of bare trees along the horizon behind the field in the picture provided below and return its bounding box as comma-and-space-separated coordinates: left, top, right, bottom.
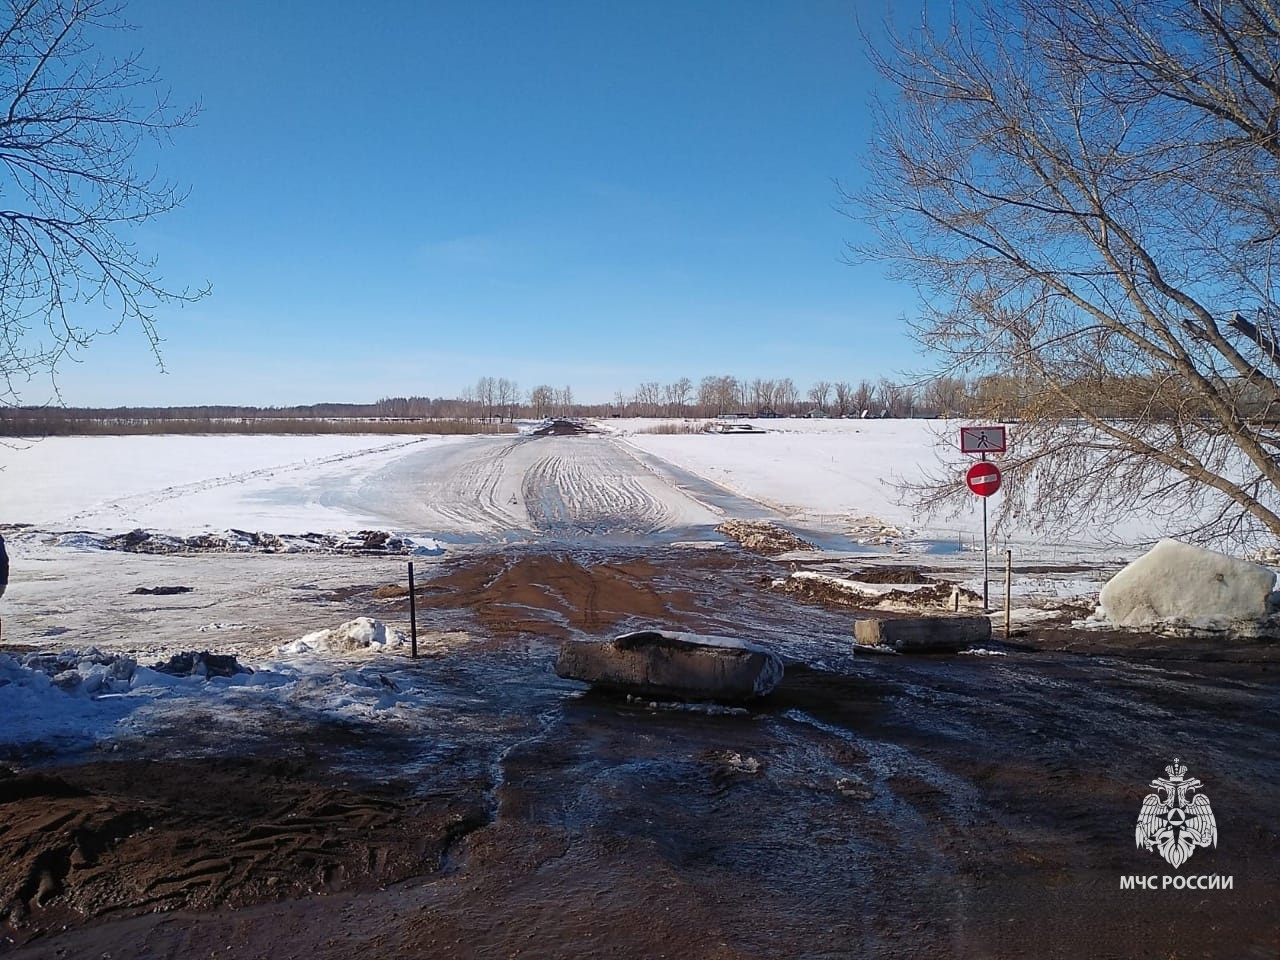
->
0, 375, 1249, 436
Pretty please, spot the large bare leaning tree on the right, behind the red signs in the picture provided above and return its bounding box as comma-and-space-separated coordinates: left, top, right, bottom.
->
859, 0, 1280, 539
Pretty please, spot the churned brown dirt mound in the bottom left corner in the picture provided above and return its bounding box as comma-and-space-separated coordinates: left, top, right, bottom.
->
0, 758, 488, 941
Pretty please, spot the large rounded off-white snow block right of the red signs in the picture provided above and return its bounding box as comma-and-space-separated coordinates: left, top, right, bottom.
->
1100, 540, 1276, 628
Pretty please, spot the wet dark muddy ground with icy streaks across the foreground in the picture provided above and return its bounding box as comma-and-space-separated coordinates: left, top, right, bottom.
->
0, 549, 1280, 960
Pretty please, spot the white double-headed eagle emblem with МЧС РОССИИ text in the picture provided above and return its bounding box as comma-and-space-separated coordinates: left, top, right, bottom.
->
1120, 756, 1233, 890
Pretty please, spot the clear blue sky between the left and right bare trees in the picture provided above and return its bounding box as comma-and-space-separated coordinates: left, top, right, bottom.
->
55, 0, 919, 406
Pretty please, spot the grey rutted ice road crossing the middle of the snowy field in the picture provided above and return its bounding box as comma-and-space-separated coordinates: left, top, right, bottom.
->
337, 435, 723, 539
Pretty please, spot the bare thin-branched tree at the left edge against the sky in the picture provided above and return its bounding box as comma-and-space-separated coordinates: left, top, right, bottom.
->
0, 0, 207, 404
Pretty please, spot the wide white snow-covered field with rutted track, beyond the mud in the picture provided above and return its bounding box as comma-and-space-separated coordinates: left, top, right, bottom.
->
0, 420, 1187, 559
